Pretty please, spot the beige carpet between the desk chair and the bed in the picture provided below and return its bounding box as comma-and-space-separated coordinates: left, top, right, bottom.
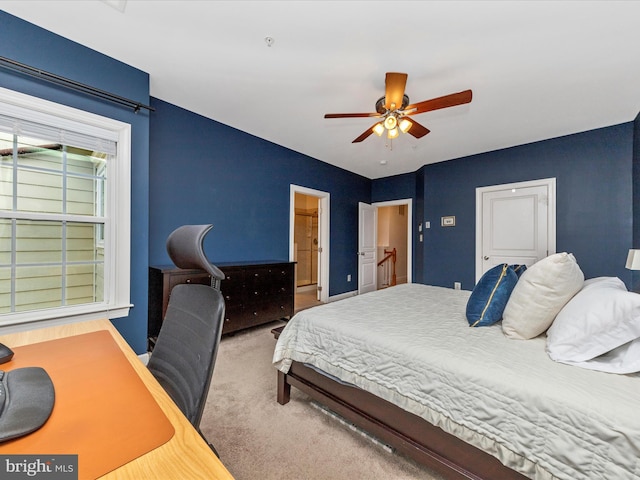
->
201, 323, 442, 480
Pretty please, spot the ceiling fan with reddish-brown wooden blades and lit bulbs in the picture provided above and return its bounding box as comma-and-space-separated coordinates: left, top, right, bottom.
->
324, 72, 472, 143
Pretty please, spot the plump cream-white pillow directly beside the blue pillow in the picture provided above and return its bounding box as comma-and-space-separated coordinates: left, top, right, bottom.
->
502, 252, 584, 340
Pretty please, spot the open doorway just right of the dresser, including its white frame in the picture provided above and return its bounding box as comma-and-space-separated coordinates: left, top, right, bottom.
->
289, 185, 329, 312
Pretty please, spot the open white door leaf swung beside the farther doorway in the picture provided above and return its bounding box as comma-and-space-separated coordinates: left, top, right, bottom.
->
358, 202, 377, 294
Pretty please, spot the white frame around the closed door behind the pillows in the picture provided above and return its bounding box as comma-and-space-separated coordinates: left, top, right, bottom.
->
476, 177, 556, 283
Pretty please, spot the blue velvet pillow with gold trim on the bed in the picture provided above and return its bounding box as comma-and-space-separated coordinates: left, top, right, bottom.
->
467, 263, 527, 327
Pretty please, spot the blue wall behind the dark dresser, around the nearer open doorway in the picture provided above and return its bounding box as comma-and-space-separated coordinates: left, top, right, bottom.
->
149, 98, 371, 295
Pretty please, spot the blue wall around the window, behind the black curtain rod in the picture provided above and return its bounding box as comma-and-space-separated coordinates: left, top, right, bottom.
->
0, 11, 149, 353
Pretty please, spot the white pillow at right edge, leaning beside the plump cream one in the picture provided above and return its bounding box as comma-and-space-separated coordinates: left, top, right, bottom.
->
547, 277, 640, 363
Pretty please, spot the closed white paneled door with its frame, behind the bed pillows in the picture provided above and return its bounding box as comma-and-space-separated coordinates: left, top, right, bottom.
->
476, 179, 555, 281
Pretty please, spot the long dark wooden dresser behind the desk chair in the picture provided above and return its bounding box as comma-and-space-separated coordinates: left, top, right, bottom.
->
148, 261, 295, 349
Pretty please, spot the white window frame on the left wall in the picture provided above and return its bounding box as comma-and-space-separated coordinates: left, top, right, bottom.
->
0, 87, 133, 333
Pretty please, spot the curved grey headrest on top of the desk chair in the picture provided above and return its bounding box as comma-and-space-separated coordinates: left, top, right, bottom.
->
167, 225, 224, 289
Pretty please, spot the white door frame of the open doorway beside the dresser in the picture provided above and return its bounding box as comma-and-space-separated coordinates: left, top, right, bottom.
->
289, 183, 331, 303
